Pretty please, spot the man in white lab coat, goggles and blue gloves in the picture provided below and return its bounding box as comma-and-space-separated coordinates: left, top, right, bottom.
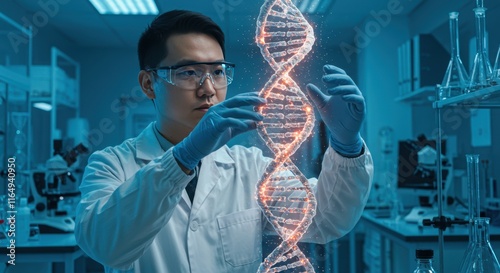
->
75, 11, 373, 273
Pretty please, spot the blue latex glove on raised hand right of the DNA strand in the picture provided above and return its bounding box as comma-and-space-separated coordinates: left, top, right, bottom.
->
307, 65, 365, 157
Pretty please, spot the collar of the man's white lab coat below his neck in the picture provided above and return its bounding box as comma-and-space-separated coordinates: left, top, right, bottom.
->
135, 122, 234, 165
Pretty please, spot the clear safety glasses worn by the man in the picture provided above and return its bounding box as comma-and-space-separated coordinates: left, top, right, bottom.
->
146, 62, 235, 90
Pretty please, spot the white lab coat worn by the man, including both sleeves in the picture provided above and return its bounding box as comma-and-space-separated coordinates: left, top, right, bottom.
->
75, 124, 373, 273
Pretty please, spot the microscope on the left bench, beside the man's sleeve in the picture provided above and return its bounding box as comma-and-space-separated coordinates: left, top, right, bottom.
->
30, 140, 88, 233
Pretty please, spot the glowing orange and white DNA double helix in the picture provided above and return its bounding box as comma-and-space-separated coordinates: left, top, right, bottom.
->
256, 0, 316, 272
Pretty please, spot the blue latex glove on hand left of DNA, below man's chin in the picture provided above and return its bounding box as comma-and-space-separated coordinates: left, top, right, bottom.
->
172, 93, 266, 170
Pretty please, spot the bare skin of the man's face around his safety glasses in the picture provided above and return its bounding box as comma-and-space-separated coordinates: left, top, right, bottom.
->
154, 33, 227, 142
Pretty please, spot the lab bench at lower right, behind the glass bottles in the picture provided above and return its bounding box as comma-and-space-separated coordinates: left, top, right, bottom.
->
360, 210, 500, 273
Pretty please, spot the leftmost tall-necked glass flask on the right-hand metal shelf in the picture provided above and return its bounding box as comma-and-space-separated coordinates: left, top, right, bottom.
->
439, 11, 469, 100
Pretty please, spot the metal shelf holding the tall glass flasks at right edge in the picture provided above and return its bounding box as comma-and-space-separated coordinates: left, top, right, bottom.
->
432, 85, 500, 108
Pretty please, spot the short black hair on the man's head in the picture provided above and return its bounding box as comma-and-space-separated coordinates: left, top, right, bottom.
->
137, 10, 225, 70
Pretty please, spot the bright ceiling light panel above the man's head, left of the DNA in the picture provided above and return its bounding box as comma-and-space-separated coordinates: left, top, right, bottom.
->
89, 0, 158, 15
